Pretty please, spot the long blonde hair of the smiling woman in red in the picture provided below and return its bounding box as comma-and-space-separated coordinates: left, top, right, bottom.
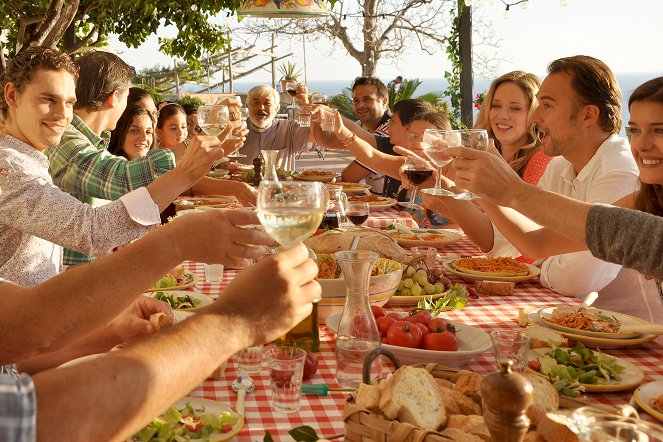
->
474, 71, 541, 177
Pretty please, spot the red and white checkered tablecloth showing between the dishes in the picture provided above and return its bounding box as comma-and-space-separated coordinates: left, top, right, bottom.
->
180, 231, 663, 441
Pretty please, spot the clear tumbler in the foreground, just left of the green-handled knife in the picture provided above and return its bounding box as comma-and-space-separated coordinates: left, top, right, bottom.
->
266, 346, 306, 413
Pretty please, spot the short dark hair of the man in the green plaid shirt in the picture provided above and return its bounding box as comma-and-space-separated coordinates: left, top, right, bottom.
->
74, 51, 136, 112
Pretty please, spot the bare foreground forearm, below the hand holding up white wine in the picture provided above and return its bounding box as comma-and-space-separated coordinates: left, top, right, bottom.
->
34, 313, 251, 441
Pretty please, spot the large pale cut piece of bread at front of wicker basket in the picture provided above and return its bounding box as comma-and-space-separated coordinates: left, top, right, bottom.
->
380, 365, 447, 430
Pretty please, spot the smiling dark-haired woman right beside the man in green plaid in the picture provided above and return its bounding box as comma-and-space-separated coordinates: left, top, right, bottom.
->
108, 105, 156, 160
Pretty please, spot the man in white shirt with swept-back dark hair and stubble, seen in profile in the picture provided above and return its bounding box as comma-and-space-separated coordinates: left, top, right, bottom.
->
426, 56, 660, 320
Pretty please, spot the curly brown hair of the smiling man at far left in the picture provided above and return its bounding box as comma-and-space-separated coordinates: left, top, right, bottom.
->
0, 46, 78, 120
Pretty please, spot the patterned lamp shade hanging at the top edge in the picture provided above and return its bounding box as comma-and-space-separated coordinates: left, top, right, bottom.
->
237, 0, 329, 18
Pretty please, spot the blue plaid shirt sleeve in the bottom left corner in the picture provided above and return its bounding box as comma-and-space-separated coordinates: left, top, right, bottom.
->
0, 365, 37, 442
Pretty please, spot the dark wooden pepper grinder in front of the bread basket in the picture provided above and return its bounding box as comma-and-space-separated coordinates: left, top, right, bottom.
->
481, 359, 533, 442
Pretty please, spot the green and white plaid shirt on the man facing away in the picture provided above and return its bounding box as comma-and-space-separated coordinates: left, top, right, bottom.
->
44, 115, 175, 265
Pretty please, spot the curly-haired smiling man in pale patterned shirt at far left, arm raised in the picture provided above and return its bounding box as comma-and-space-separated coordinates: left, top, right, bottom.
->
0, 47, 223, 287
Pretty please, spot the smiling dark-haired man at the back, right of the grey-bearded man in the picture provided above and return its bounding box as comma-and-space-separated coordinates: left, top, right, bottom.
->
341, 77, 391, 194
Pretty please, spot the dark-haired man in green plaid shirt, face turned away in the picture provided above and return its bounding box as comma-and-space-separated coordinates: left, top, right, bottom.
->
45, 51, 253, 265
